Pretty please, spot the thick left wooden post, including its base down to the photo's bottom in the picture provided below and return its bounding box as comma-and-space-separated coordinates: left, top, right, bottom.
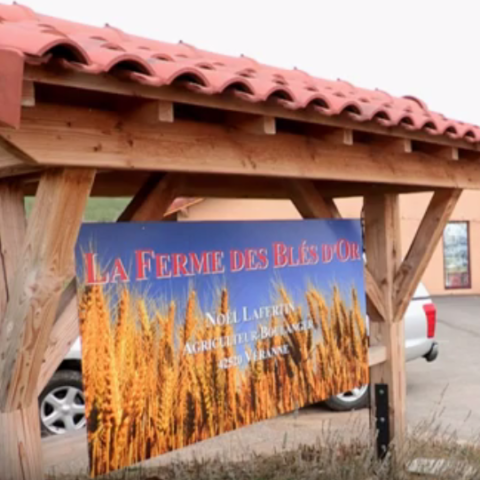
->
0, 169, 94, 480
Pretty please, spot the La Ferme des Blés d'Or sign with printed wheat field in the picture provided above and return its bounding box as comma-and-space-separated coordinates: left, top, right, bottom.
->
76, 220, 368, 476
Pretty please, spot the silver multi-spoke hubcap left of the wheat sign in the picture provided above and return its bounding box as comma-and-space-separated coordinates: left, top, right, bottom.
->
40, 386, 85, 434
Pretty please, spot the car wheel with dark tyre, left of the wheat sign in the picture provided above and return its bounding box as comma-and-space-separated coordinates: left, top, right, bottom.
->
39, 370, 86, 435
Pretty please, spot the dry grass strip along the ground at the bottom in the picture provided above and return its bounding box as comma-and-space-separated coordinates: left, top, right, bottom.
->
47, 430, 480, 480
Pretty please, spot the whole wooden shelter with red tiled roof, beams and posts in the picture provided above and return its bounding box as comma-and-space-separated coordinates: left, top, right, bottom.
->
0, 1, 480, 480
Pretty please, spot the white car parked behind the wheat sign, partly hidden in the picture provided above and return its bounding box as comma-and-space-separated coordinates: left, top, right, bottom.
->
39, 284, 438, 435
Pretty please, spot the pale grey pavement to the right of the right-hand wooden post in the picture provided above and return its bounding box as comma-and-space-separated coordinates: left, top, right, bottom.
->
407, 297, 480, 438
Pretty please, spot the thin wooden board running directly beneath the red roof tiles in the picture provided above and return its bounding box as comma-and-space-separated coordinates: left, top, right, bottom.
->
24, 65, 480, 151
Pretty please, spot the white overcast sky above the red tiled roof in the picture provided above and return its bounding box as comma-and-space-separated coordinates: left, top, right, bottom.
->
23, 0, 480, 125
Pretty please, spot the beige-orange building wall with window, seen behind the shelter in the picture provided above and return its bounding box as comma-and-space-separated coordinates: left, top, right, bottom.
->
172, 191, 480, 295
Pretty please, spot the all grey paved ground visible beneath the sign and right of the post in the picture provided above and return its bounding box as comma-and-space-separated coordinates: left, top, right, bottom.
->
45, 297, 480, 473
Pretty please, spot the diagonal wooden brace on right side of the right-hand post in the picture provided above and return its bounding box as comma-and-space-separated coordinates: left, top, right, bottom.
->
394, 190, 462, 322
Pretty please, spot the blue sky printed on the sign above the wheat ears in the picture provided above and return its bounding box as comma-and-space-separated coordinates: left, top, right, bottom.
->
76, 220, 366, 346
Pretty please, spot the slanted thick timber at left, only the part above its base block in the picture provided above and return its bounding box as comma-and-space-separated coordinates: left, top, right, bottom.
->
0, 169, 94, 411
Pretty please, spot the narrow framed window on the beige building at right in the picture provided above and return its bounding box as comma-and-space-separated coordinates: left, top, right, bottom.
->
443, 222, 472, 289
